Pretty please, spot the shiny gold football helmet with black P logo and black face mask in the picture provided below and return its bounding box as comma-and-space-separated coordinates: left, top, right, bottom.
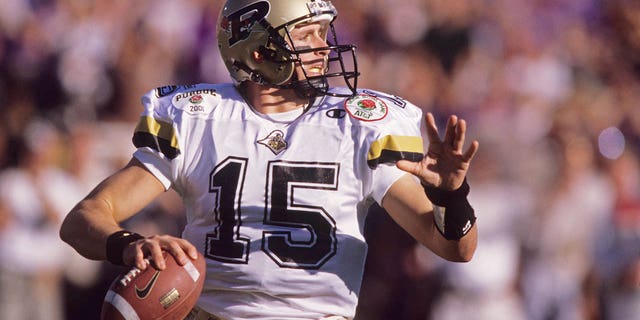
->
217, 0, 359, 97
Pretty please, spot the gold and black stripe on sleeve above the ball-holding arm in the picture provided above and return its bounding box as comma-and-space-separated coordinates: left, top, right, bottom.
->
132, 117, 180, 160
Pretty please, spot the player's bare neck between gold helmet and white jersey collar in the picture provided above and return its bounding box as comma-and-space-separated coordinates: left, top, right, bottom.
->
238, 82, 309, 114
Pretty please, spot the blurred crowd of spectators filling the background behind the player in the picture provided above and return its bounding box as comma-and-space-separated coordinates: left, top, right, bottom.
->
0, 0, 640, 320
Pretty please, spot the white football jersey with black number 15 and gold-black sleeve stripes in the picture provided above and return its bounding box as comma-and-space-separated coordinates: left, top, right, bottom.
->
133, 84, 423, 320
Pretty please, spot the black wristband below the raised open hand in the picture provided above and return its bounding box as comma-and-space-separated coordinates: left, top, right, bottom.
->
423, 178, 476, 240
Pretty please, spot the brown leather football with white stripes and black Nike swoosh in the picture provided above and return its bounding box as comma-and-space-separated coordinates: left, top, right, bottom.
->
100, 251, 206, 320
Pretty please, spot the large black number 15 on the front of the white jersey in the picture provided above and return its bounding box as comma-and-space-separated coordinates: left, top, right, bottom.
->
206, 157, 340, 269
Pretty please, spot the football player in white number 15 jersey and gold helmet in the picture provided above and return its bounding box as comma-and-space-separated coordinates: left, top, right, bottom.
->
60, 0, 478, 320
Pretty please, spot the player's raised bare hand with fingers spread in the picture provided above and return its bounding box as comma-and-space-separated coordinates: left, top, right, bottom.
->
396, 113, 480, 190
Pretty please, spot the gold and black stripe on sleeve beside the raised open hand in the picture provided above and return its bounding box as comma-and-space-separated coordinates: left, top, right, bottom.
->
367, 135, 424, 169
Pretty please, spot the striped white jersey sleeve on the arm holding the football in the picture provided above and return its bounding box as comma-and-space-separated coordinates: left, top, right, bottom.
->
132, 87, 181, 189
